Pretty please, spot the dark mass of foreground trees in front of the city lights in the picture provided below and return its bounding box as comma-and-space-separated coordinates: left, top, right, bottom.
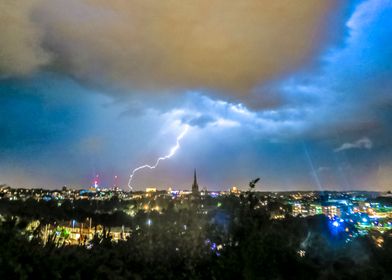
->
0, 184, 392, 279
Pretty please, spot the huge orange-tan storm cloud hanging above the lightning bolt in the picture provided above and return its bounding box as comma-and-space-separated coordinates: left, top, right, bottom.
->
0, 0, 338, 99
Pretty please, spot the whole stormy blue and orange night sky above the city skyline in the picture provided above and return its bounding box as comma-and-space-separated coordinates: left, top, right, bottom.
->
0, 0, 392, 190
